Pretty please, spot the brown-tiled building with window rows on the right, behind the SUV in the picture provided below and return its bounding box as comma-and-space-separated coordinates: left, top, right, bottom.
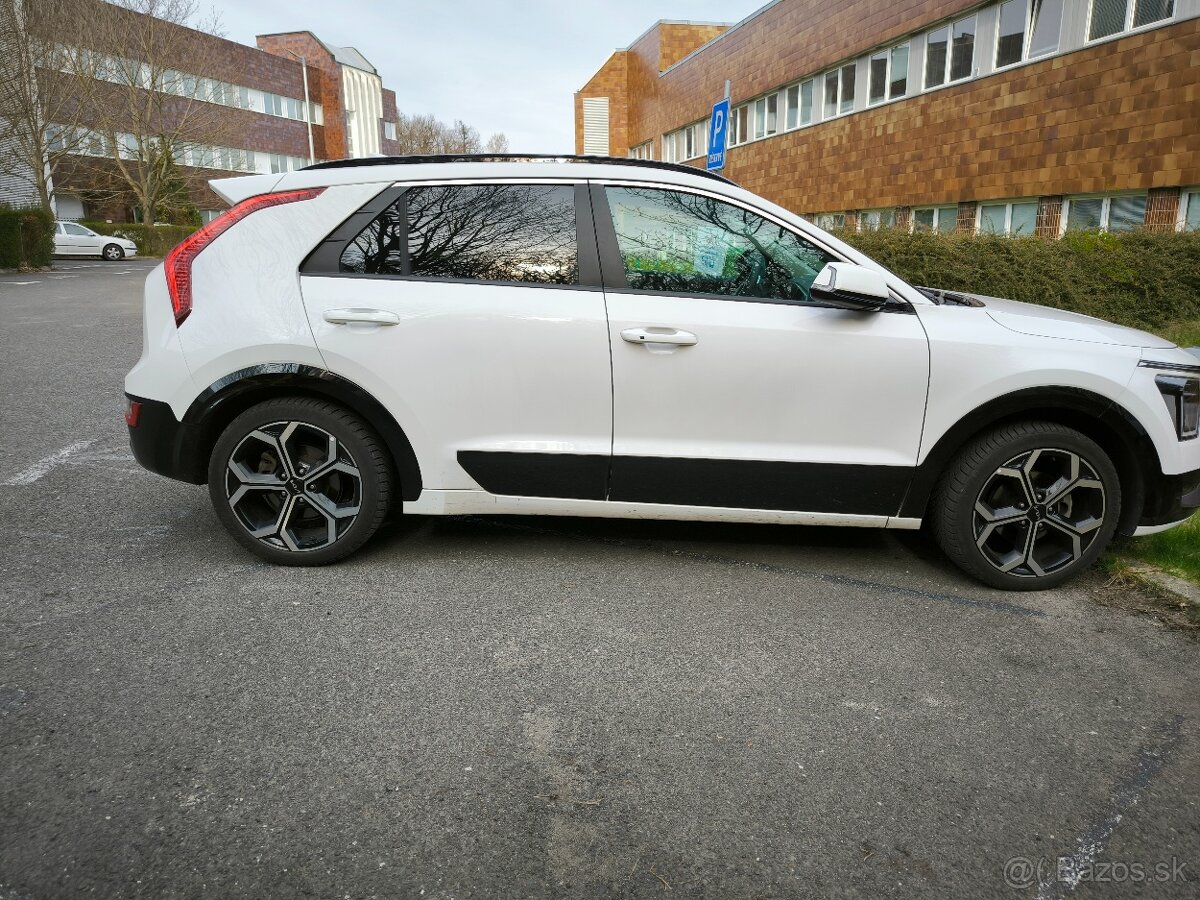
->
575, 0, 1200, 235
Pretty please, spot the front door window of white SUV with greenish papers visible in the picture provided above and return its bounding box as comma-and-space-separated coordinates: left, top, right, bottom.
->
606, 187, 836, 302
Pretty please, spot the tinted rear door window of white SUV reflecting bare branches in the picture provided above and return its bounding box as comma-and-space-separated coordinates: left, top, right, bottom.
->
340, 185, 578, 284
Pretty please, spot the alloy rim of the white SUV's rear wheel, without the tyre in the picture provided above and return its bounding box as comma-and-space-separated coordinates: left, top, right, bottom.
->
226, 421, 362, 553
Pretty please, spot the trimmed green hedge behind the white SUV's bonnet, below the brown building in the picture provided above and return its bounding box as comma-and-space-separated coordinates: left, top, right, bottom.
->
839, 229, 1200, 330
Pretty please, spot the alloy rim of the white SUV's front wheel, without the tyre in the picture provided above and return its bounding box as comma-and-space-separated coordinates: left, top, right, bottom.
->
973, 448, 1105, 578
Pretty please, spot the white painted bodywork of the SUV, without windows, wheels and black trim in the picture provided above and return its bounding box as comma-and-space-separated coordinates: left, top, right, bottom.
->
126, 162, 1200, 573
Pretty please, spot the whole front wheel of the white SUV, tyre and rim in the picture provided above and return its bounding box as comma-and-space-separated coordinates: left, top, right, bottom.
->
929, 421, 1121, 590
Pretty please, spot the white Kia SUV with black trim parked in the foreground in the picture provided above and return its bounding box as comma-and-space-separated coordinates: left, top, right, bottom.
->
125, 157, 1200, 589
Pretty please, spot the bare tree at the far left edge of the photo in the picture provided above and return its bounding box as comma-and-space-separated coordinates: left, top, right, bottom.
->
0, 0, 98, 209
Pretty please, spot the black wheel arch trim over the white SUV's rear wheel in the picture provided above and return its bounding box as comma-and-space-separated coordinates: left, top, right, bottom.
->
182, 362, 421, 500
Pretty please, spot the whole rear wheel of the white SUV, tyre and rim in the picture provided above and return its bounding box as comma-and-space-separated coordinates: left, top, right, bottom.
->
209, 397, 396, 565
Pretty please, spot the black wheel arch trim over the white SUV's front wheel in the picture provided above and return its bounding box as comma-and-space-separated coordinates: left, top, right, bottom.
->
900, 385, 1165, 534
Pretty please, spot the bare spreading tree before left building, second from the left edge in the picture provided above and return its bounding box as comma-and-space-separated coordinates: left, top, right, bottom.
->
54, 0, 239, 224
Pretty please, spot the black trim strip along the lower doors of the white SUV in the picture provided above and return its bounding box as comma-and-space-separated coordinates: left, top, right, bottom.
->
458, 450, 913, 516
